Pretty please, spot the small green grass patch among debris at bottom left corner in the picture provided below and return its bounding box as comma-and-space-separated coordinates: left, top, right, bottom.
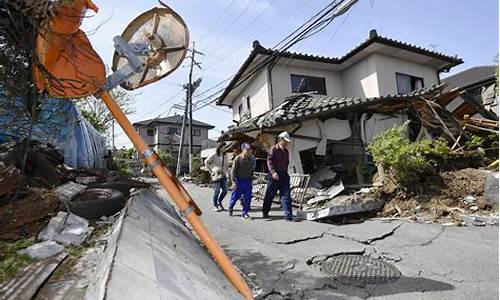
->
0, 238, 35, 284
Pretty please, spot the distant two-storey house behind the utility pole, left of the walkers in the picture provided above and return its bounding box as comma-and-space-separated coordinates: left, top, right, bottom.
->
133, 115, 214, 170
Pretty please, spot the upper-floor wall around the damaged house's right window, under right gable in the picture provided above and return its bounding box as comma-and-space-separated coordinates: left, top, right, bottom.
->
371, 53, 438, 96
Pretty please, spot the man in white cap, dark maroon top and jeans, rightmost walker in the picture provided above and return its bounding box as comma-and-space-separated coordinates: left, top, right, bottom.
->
262, 131, 293, 221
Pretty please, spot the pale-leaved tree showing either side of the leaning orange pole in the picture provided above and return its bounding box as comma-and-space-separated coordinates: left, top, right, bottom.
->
76, 87, 137, 133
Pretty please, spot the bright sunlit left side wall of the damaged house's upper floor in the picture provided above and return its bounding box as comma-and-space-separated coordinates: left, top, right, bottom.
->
232, 68, 271, 121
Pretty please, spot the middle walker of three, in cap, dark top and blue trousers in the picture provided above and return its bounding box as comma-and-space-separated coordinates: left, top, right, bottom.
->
228, 143, 253, 219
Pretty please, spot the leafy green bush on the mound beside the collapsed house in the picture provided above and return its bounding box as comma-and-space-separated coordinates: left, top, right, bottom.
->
368, 123, 454, 187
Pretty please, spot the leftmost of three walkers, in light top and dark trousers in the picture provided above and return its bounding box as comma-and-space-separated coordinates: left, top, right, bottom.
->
205, 143, 229, 211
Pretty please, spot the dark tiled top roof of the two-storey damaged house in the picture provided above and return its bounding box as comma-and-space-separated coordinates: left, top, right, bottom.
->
217, 30, 463, 105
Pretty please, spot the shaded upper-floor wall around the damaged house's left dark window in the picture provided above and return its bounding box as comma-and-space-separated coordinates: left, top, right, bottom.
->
271, 60, 344, 107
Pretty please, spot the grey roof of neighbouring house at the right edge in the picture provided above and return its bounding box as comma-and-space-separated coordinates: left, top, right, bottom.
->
442, 66, 497, 89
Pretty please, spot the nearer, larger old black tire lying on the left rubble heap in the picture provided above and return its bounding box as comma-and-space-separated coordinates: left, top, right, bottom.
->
67, 188, 127, 219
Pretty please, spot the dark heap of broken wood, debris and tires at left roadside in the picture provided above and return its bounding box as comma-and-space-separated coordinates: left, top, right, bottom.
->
0, 142, 148, 240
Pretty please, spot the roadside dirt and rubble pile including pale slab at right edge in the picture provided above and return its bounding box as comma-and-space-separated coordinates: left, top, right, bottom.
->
379, 168, 498, 225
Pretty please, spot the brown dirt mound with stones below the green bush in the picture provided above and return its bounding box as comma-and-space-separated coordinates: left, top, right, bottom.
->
380, 168, 498, 221
